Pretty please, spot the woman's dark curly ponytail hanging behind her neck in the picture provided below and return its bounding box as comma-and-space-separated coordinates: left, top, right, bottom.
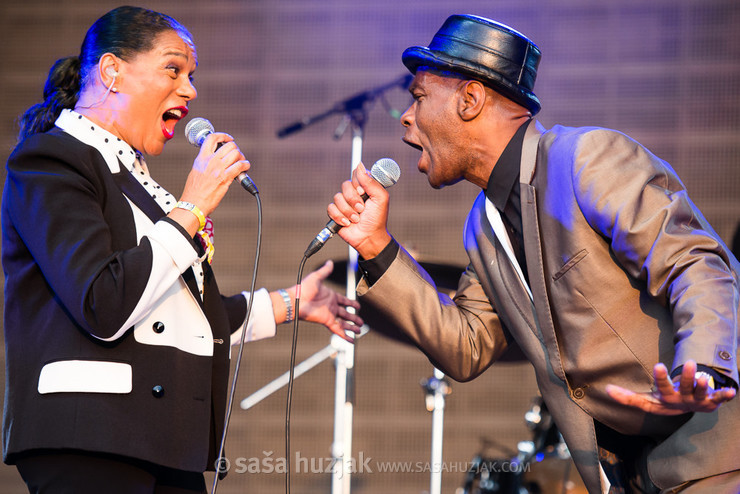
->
18, 56, 80, 142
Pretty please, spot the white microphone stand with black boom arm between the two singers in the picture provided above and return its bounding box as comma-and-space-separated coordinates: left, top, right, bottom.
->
240, 74, 413, 494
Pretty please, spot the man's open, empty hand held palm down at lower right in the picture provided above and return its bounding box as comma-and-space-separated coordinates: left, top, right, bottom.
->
606, 360, 736, 415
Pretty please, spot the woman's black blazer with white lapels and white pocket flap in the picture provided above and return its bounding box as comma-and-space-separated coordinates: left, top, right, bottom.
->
2, 127, 246, 471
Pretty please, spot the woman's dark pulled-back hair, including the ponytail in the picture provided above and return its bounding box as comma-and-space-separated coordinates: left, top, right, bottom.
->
18, 6, 193, 141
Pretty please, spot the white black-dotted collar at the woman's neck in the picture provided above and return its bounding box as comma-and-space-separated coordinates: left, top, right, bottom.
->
55, 109, 136, 173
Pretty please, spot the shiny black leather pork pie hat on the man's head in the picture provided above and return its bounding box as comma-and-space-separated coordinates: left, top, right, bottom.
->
401, 15, 542, 115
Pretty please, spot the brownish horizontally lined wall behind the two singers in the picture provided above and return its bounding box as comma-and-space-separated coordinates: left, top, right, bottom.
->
0, 0, 740, 494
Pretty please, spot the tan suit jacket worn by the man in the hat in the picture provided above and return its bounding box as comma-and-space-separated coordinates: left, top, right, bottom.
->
358, 120, 740, 492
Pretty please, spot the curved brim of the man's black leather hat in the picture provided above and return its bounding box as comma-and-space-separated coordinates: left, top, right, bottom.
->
401, 46, 542, 115
